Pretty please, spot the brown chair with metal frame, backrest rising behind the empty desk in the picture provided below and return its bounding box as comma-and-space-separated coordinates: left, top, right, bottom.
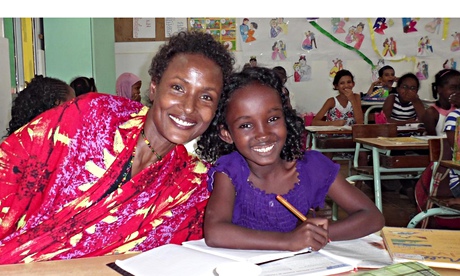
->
332, 124, 426, 220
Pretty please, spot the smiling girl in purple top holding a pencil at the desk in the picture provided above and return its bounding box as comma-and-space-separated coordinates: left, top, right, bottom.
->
197, 67, 384, 251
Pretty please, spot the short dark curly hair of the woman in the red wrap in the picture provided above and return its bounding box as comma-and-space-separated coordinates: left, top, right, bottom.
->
149, 31, 235, 88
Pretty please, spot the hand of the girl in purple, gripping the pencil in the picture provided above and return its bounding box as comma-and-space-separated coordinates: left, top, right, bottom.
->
288, 218, 329, 251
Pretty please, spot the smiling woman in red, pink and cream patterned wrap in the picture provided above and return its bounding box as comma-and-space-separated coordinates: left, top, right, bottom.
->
0, 32, 233, 264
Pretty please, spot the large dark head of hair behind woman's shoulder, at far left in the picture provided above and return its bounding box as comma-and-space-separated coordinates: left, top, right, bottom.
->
7, 75, 75, 135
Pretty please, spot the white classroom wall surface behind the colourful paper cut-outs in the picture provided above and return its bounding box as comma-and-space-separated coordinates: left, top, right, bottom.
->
115, 18, 460, 113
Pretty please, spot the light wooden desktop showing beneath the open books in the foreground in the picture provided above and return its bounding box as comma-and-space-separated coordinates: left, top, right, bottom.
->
0, 249, 459, 276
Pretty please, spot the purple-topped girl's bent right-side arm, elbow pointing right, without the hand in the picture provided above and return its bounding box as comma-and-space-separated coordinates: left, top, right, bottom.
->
328, 173, 385, 241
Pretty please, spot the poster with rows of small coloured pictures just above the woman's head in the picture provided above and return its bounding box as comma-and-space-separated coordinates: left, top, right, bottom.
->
189, 18, 236, 51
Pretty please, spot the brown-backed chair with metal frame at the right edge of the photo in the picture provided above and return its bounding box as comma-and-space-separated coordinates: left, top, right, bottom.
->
407, 138, 460, 228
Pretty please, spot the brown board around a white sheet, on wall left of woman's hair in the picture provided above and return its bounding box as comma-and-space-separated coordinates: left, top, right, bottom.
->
114, 18, 165, 42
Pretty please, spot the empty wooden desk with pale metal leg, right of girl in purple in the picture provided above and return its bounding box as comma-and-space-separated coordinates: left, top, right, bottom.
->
355, 137, 428, 211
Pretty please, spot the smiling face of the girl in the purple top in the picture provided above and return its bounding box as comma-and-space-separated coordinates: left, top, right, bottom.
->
220, 83, 287, 167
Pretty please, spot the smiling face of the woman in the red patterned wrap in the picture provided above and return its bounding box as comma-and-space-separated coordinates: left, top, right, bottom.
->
146, 54, 223, 144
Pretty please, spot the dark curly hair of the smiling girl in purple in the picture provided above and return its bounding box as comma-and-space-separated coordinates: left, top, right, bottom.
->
196, 67, 305, 163
